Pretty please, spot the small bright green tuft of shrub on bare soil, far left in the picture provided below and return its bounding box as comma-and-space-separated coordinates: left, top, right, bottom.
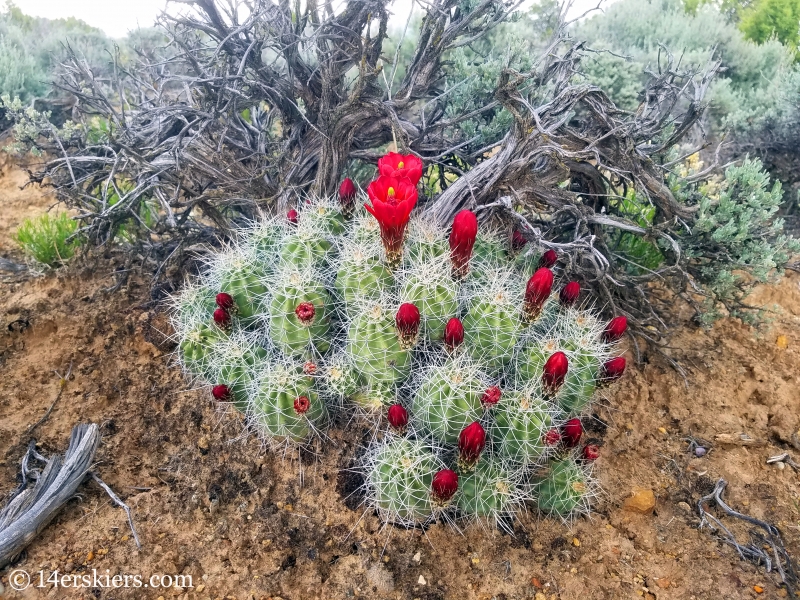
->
14, 213, 80, 267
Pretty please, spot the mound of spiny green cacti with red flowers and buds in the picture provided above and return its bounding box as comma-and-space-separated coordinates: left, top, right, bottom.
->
173, 153, 627, 525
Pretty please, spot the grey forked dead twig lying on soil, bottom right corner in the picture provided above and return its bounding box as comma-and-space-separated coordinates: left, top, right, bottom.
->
697, 479, 800, 598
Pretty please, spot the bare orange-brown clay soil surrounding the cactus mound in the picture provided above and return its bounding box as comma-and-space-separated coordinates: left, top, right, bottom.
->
0, 158, 800, 600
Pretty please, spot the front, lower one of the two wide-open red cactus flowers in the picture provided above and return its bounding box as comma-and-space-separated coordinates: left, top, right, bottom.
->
364, 176, 418, 266
